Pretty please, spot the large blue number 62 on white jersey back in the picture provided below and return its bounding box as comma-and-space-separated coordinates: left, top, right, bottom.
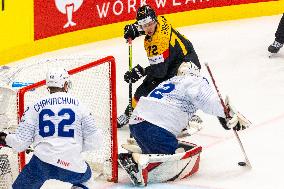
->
39, 108, 75, 137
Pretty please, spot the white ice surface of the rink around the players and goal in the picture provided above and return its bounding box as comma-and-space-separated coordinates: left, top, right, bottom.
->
7, 15, 284, 189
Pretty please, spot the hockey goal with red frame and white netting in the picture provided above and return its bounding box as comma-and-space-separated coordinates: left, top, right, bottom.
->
0, 56, 118, 189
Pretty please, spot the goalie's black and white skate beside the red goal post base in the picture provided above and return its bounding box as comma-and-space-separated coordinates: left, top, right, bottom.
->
118, 153, 141, 186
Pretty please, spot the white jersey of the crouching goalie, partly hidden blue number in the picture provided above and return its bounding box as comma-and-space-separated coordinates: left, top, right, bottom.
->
130, 76, 225, 136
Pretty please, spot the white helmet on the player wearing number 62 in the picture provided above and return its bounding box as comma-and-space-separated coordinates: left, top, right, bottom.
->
46, 68, 71, 88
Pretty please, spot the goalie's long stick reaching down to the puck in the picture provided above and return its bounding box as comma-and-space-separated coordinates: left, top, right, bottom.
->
205, 63, 252, 168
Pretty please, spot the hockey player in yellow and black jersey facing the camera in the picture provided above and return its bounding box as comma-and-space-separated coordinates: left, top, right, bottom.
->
117, 5, 201, 128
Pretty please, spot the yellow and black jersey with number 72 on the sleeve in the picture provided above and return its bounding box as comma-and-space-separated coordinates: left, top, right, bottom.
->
144, 16, 201, 80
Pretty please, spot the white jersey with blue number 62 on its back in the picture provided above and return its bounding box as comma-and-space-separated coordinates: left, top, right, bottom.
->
6, 92, 103, 173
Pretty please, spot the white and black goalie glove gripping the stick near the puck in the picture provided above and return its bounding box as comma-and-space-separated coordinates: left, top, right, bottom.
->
218, 96, 251, 131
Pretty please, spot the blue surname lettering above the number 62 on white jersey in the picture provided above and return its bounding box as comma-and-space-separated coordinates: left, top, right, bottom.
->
34, 97, 79, 112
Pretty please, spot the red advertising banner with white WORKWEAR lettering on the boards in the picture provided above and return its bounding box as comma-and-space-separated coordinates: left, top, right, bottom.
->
34, 0, 273, 40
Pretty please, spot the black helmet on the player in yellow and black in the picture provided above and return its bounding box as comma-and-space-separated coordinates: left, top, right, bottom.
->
136, 5, 157, 25
